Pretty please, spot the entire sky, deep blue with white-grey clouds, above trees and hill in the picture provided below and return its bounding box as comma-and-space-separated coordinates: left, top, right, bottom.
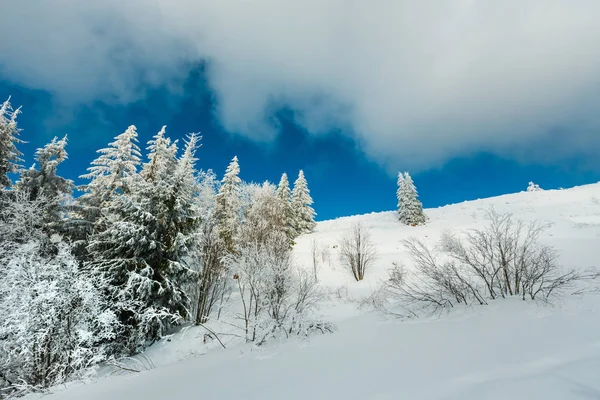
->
0, 0, 600, 220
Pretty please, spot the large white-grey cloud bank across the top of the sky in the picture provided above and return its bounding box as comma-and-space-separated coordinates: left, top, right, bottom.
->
0, 0, 600, 168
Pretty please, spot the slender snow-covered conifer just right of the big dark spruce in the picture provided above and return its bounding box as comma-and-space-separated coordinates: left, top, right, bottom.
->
216, 156, 242, 252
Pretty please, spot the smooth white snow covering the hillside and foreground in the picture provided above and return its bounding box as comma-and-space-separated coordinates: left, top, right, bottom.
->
30, 184, 600, 400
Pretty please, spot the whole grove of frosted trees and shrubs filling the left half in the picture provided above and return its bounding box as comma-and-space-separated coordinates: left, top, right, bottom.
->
0, 101, 324, 392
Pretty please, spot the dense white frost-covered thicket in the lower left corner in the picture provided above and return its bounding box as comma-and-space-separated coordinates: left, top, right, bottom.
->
0, 192, 119, 393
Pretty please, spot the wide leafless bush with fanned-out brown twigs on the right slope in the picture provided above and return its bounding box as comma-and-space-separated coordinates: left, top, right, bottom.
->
384, 210, 599, 315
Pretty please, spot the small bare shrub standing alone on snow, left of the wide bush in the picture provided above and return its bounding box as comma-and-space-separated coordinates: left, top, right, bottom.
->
340, 223, 377, 281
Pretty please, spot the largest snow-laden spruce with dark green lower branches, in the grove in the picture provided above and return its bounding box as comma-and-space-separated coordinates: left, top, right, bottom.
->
88, 130, 198, 353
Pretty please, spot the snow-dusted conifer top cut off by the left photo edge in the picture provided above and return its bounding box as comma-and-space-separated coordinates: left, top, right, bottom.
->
0, 97, 23, 189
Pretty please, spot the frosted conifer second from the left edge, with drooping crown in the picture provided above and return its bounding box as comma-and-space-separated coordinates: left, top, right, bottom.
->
15, 136, 74, 232
